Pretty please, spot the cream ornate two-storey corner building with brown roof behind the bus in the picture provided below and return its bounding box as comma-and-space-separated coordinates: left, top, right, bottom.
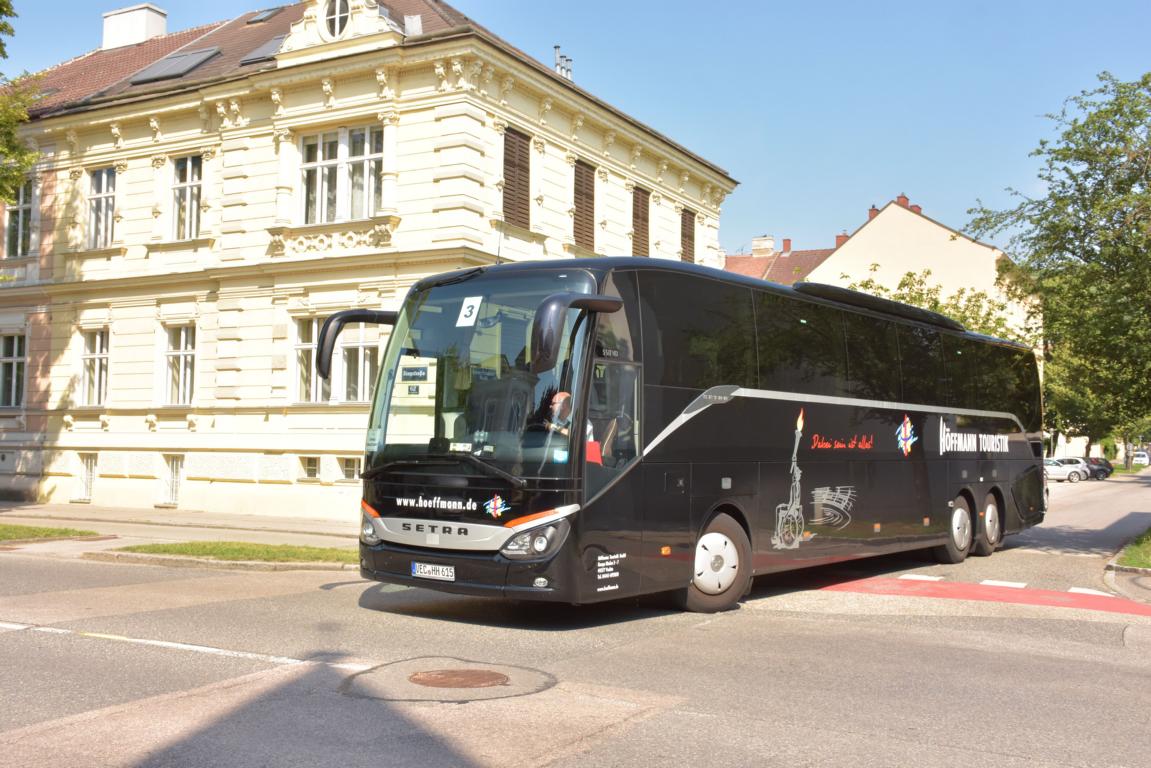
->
0, 0, 735, 519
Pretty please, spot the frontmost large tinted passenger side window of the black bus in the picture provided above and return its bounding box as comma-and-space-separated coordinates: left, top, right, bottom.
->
640, 272, 756, 389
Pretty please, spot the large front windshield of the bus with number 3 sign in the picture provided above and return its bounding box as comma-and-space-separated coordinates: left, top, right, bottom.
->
365, 269, 596, 484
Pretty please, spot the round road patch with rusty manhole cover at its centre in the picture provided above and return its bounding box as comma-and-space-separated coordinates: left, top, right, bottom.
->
340, 656, 556, 704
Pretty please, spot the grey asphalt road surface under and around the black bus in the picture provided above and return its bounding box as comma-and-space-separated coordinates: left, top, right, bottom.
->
0, 478, 1151, 767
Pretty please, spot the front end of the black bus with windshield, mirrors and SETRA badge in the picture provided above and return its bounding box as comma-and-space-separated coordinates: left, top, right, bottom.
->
319, 266, 622, 602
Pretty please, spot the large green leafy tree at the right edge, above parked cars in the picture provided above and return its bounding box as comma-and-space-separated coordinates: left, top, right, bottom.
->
969, 73, 1151, 460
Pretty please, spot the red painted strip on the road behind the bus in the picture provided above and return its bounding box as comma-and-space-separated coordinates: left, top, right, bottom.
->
823, 577, 1151, 616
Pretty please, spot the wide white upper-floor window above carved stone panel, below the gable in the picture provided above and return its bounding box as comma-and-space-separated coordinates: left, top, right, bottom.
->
298, 124, 386, 226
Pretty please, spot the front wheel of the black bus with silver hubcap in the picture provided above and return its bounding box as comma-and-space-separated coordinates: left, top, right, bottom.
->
677, 514, 752, 614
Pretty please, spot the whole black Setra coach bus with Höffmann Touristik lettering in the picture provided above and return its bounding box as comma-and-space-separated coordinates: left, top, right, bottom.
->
318, 258, 1045, 611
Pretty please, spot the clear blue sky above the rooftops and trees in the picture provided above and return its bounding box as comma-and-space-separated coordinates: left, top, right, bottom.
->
8, 0, 1151, 252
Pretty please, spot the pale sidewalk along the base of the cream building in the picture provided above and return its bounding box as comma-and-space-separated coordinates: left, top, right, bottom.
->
0, 502, 359, 557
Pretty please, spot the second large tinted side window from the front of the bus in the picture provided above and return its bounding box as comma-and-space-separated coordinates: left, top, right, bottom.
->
755, 294, 847, 395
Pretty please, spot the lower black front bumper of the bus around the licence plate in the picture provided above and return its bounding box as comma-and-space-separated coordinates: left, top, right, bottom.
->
360, 542, 578, 603
